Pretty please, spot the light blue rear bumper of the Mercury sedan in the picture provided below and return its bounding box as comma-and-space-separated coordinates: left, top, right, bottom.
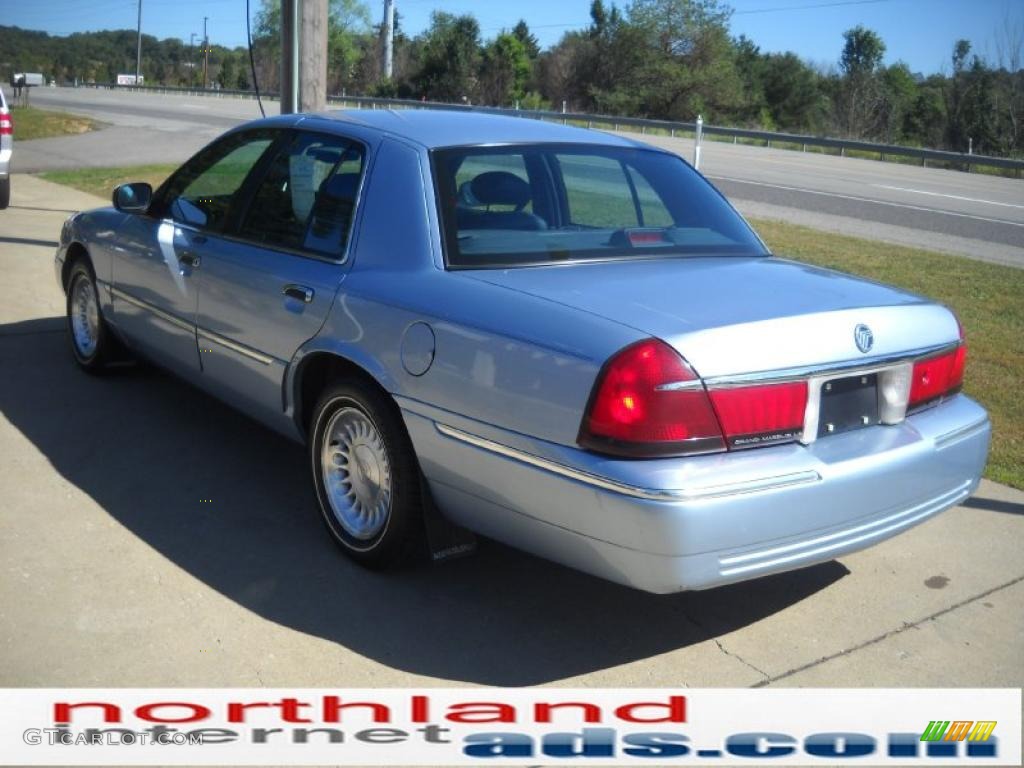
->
404, 395, 990, 593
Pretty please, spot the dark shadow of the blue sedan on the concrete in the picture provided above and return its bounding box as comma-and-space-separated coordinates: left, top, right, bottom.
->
0, 317, 848, 686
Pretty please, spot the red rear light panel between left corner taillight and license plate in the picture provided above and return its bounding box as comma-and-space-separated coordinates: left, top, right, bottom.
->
711, 381, 807, 447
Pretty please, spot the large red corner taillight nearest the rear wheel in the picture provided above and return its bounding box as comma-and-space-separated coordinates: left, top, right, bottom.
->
580, 339, 725, 456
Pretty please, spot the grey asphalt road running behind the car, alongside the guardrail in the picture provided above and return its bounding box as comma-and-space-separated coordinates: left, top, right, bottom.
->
14, 88, 1024, 267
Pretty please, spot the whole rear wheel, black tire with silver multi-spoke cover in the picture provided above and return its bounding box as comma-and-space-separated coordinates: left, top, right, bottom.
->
309, 381, 425, 569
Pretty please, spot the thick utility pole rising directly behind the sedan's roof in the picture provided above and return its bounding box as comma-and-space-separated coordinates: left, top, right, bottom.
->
281, 0, 328, 115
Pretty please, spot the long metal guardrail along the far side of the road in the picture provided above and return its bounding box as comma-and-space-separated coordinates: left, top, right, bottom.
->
88, 85, 1024, 177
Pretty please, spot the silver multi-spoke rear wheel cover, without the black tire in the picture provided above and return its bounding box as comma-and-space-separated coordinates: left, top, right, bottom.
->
321, 407, 391, 541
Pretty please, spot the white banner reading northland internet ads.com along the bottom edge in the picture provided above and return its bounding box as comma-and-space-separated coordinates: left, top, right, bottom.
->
0, 688, 1021, 766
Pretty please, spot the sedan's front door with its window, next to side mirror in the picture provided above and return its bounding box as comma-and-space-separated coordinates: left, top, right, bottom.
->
111, 128, 282, 378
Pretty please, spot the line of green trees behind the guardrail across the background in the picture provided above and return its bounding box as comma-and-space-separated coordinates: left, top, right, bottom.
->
0, 0, 1024, 156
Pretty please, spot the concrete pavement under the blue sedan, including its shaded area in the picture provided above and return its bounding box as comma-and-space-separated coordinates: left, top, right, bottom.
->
0, 176, 1024, 687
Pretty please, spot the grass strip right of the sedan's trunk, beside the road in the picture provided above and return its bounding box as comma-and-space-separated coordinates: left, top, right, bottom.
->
751, 219, 1024, 488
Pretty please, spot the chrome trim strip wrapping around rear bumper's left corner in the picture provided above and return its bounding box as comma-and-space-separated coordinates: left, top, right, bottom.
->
434, 422, 821, 502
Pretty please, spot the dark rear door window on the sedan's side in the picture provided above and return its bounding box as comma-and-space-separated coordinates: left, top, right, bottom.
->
239, 132, 365, 258
